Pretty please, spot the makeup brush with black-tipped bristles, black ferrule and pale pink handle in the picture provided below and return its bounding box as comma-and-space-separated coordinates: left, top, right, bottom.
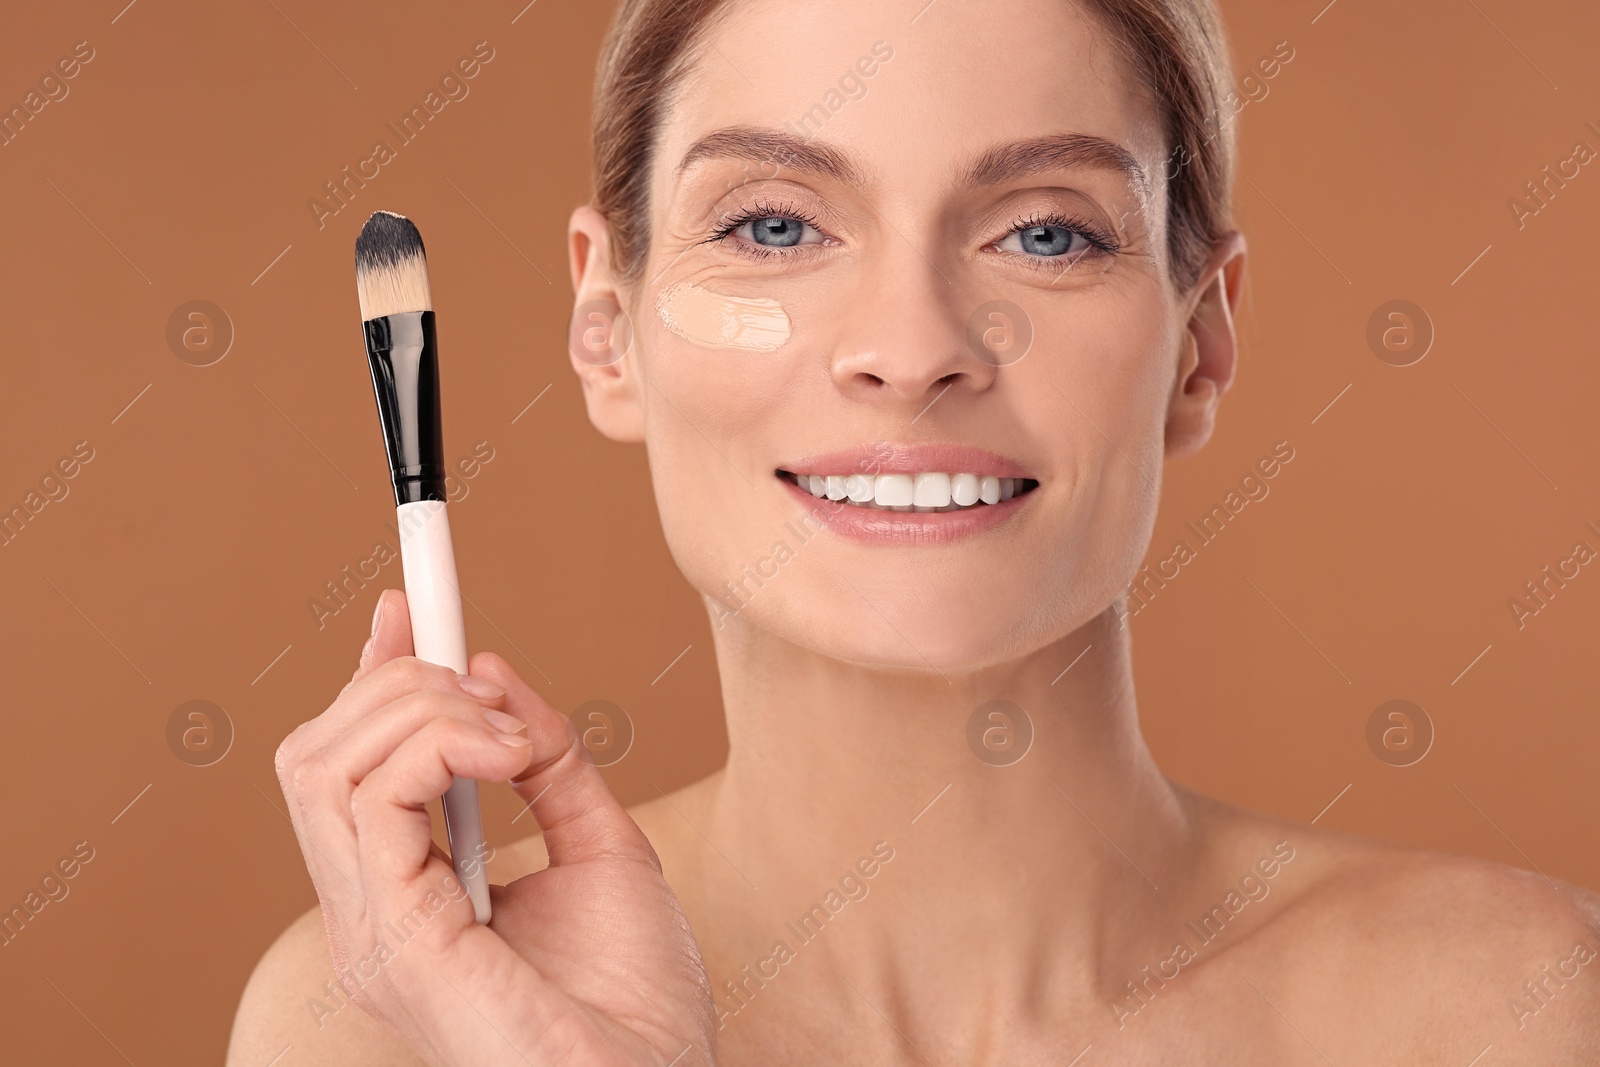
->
355, 211, 490, 923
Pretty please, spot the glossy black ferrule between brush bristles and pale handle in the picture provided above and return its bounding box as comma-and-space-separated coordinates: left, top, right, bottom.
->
362, 310, 445, 507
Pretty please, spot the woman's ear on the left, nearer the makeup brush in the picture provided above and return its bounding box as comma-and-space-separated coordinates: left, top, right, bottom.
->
566, 205, 645, 442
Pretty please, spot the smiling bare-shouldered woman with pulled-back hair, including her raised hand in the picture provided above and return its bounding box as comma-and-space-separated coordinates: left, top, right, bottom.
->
230, 0, 1600, 1065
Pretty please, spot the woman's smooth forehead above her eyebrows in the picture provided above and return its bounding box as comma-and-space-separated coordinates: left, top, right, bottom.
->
654, 0, 1165, 195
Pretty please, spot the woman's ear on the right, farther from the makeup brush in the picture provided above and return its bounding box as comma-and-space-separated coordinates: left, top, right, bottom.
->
1166, 230, 1245, 459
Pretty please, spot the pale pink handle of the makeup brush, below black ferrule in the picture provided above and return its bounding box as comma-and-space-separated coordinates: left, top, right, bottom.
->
397, 501, 490, 923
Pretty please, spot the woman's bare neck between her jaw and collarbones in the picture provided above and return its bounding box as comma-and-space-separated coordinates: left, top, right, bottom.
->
701, 611, 1195, 1017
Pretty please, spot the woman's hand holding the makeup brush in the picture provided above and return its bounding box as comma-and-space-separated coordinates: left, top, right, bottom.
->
277, 590, 714, 1067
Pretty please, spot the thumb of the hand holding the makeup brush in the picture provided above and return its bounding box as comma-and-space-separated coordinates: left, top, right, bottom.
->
470, 653, 661, 869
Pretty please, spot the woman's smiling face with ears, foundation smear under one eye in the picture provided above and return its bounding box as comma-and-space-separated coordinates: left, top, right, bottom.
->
573, 0, 1240, 670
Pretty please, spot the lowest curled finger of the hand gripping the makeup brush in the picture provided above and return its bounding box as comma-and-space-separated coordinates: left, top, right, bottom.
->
350, 718, 533, 921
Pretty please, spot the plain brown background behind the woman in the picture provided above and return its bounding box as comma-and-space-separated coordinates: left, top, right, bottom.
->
0, 0, 1600, 1064
